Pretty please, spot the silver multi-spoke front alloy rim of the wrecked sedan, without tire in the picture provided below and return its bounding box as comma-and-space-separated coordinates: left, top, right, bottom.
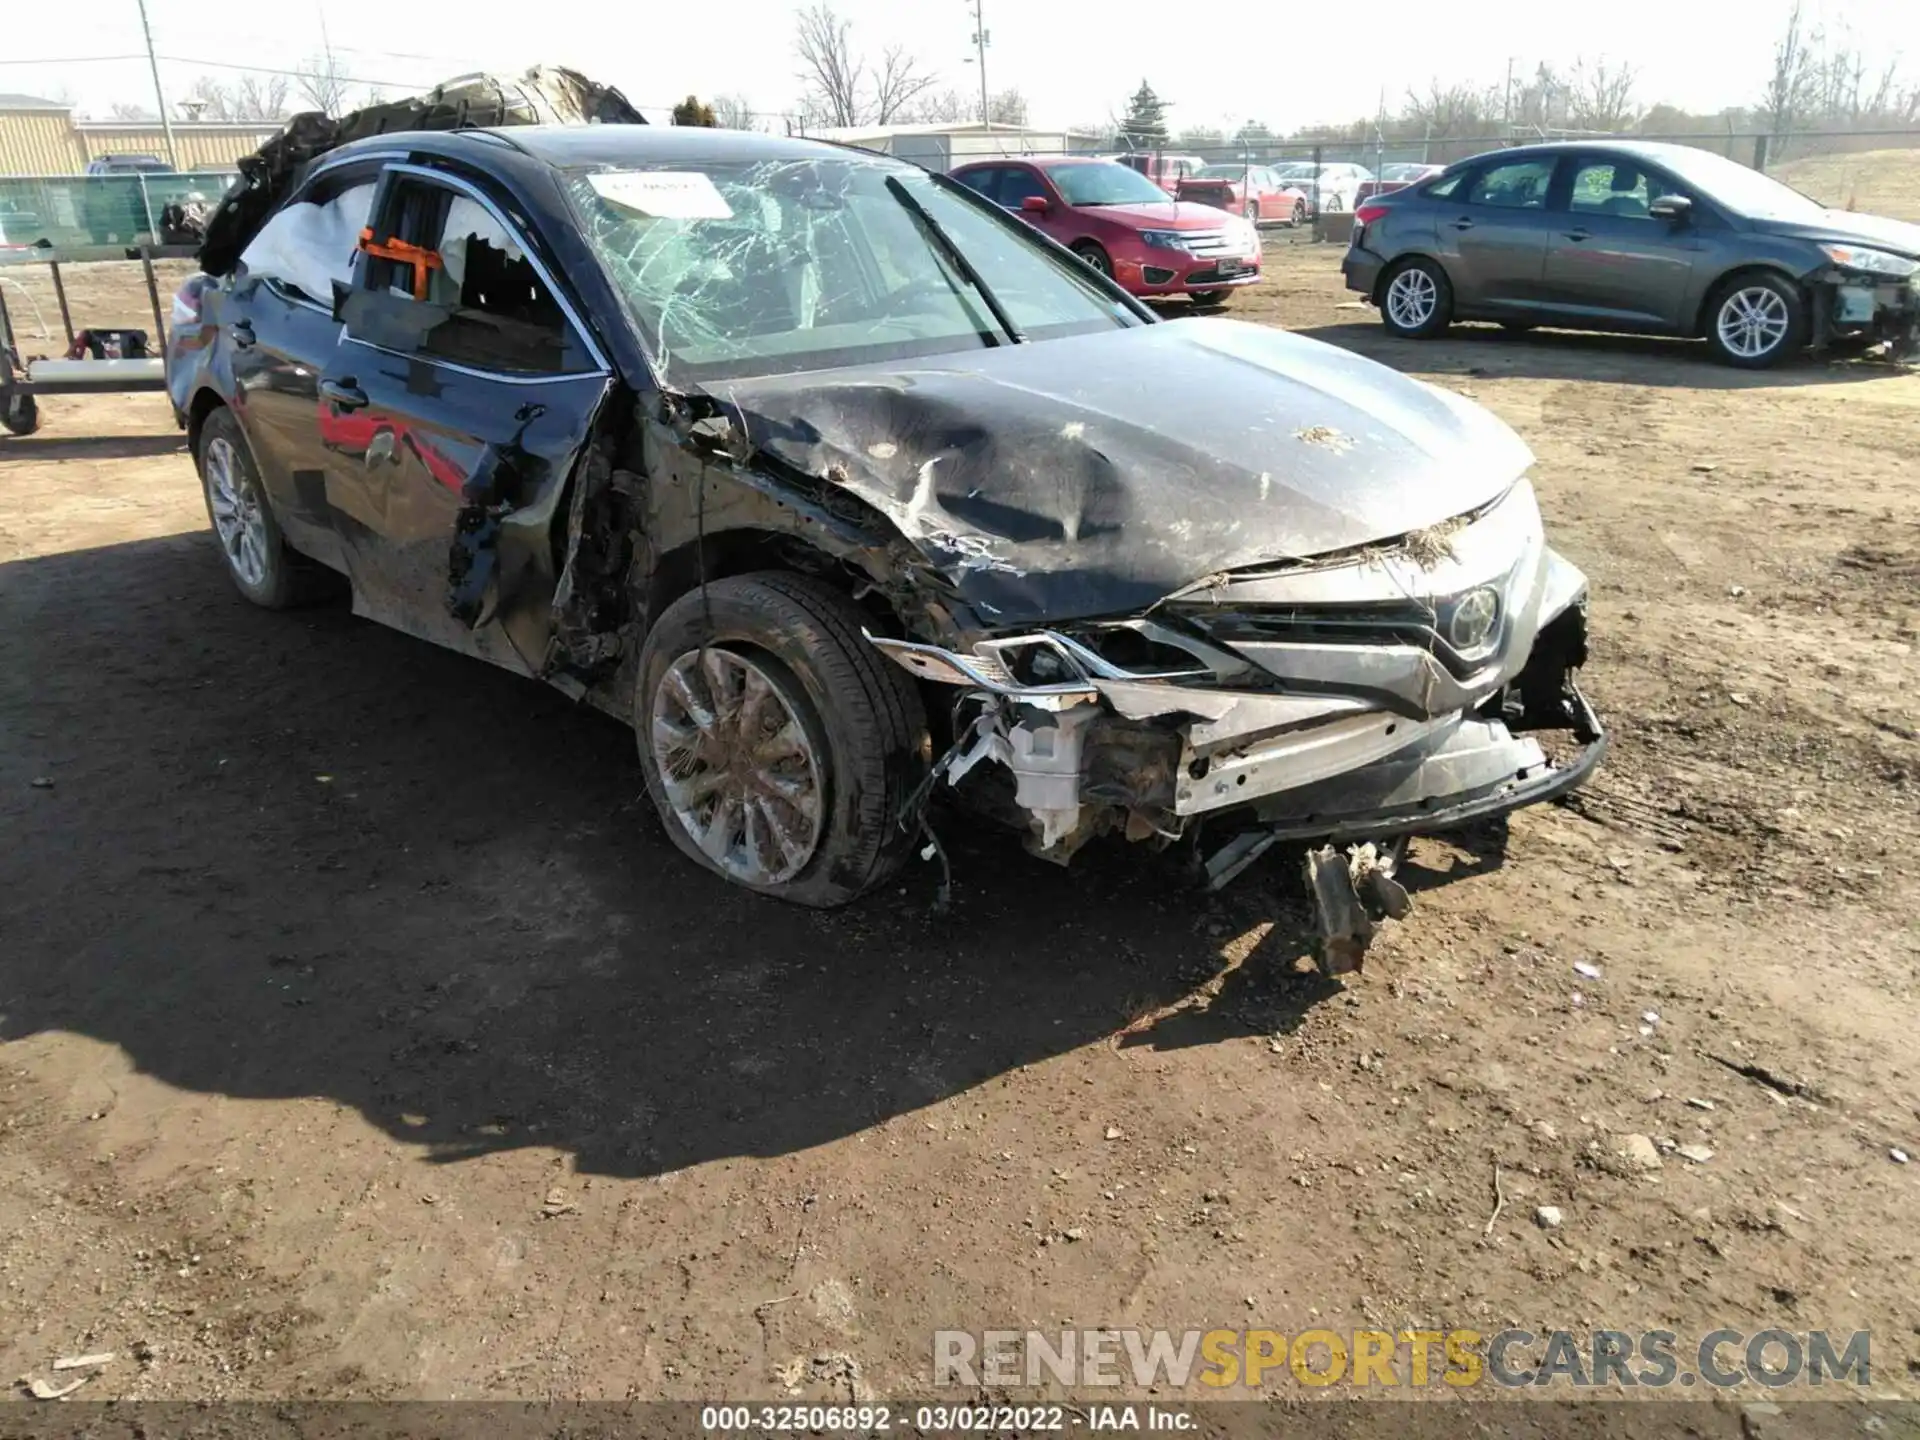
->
649, 647, 826, 885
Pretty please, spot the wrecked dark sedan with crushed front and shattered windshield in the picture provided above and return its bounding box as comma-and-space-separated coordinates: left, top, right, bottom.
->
171, 125, 1605, 940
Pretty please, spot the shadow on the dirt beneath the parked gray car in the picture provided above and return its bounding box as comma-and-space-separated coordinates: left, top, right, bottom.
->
1294, 313, 1914, 390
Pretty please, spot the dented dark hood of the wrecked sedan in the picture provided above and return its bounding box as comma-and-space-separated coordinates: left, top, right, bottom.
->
722, 319, 1532, 626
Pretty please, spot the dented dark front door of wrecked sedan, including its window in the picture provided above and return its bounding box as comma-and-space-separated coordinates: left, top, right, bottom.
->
321, 165, 612, 672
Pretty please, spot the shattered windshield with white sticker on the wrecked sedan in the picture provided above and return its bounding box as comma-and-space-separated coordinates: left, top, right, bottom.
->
566, 159, 1142, 382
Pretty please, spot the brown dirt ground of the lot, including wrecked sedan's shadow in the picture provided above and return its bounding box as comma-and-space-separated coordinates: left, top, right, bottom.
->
0, 236, 1920, 1400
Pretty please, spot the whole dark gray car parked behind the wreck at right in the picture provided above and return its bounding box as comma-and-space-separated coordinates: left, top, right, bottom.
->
1342, 142, 1920, 369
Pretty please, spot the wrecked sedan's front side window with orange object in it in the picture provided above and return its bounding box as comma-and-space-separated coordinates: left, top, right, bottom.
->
348, 175, 591, 374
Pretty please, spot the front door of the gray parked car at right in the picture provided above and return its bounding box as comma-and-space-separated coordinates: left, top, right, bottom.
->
1544, 154, 1703, 330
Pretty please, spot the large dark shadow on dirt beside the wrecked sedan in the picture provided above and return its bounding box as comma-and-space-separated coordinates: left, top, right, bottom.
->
0, 534, 1338, 1175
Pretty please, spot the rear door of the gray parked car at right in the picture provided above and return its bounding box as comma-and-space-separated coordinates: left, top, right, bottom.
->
1434, 156, 1565, 315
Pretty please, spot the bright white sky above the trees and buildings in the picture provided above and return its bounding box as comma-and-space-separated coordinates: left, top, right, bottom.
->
0, 0, 1920, 131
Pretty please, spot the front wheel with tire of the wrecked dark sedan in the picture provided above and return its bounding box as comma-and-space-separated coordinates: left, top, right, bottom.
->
634, 572, 929, 910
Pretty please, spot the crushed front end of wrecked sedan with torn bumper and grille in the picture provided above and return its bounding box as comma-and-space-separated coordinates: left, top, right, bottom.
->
874, 478, 1605, 963
